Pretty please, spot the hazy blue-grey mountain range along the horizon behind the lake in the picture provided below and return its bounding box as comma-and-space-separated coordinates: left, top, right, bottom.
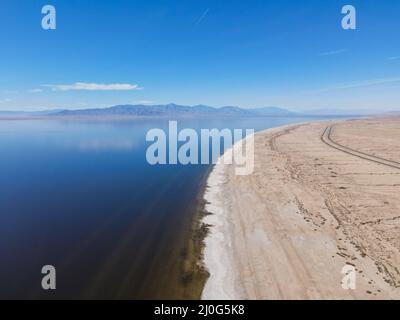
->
0, 103, 394, 118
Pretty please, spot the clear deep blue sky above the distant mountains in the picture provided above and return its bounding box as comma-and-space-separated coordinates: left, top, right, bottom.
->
0, 0, 400, 110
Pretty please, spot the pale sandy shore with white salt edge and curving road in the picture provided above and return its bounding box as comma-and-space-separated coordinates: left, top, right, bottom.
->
202, 118, 400, 299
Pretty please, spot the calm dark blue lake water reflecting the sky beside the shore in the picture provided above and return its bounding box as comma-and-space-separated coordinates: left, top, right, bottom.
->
0, 118, 328, 299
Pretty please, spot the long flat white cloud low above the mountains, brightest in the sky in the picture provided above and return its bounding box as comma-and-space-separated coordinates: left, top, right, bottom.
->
43, 82, 141, 91
